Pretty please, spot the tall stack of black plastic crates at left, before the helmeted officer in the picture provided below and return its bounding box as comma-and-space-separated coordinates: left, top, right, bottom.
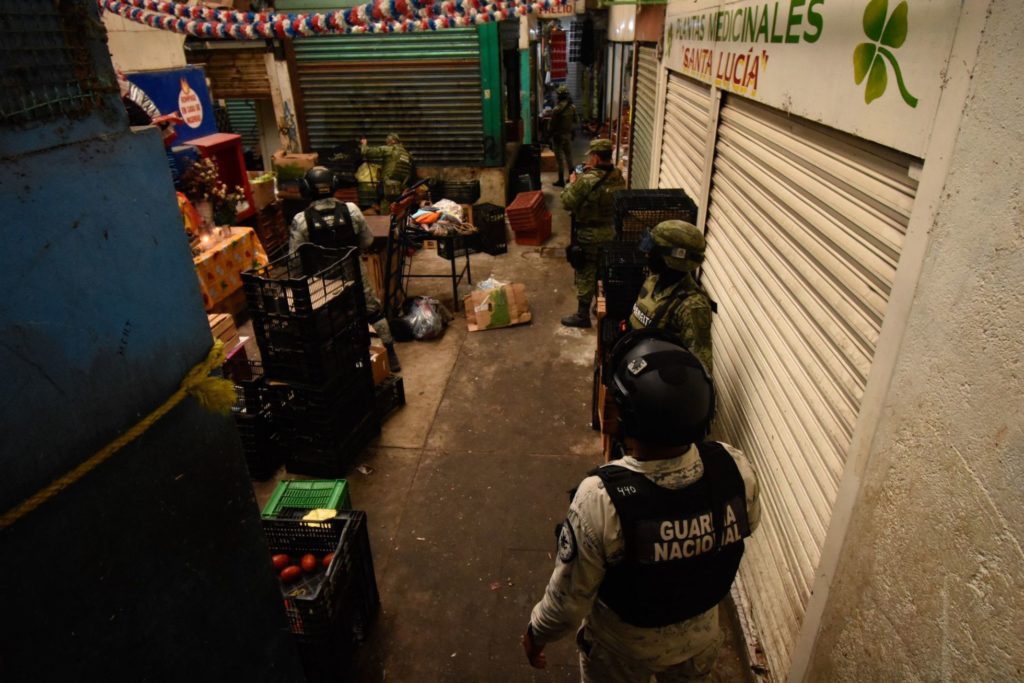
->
242, 244, 380, 477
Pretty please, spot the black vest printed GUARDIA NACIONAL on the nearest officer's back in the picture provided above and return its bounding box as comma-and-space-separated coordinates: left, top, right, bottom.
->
593, 442, 751, 628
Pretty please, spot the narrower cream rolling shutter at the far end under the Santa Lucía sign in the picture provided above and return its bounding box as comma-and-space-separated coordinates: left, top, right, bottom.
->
657, 72, 711, 201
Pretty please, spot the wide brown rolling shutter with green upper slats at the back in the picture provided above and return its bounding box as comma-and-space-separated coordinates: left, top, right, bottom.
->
295, 29, 484, 166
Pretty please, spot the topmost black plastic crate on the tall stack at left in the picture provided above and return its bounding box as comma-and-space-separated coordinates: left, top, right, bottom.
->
242, 244, 366, 316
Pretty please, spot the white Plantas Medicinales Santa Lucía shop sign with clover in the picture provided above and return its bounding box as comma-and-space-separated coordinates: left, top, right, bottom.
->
664, 0, 961, 157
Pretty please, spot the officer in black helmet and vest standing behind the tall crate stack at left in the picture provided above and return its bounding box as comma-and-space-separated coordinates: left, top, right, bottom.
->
288, 166, 401, 373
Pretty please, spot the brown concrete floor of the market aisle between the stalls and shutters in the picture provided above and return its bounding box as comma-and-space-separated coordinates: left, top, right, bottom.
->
256, 141, 745, 681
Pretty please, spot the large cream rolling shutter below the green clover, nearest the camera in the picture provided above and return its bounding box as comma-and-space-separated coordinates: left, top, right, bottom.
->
703, 97, 916, 680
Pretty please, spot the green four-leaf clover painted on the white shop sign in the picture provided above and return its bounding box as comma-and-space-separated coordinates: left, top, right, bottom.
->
853, 0, 918, 106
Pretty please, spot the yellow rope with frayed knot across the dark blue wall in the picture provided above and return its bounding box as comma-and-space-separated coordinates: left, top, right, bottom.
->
0, 341, 234, 529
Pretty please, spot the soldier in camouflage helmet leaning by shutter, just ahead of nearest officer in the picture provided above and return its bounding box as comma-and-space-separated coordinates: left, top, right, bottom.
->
630, 220, 714, 373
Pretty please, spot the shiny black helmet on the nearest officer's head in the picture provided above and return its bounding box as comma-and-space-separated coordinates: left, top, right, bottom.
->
610, 329, 715, 445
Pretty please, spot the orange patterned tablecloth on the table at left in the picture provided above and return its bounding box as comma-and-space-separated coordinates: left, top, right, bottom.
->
193, 227, 267, 310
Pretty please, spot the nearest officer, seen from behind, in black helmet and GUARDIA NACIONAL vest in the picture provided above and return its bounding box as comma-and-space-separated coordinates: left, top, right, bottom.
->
522, 330, 761, 683
